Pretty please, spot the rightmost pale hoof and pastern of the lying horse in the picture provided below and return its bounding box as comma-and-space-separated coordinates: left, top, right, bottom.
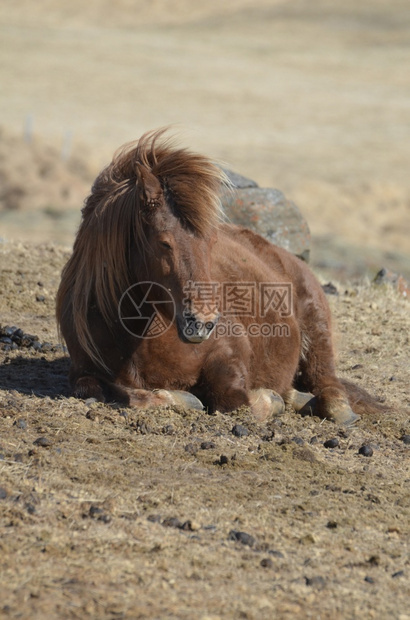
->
299, 387, 360, 426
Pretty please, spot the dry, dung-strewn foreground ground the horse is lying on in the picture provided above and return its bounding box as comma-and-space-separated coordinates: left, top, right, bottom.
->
0, 243, 410, 620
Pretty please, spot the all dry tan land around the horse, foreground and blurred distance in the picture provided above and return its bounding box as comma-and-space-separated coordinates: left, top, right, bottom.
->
0, 0, 410, 620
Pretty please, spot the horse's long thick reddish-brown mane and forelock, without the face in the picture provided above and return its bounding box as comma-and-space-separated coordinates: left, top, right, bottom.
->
57, 129, 227, 367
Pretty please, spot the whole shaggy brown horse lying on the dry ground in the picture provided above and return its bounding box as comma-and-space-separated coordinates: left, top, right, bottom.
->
57, 130, 380, 424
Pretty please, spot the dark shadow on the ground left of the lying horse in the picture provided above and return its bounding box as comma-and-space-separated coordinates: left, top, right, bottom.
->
0, 356, 70, 398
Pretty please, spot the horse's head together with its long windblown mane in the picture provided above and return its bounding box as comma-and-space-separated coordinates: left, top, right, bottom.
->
63, 130, 227, 367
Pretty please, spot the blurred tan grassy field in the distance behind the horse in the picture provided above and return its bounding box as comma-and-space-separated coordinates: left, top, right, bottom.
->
0, 0, 410, 278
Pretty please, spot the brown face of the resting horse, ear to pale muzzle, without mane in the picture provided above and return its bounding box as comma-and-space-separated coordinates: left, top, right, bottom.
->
137, 160, 219, 343
